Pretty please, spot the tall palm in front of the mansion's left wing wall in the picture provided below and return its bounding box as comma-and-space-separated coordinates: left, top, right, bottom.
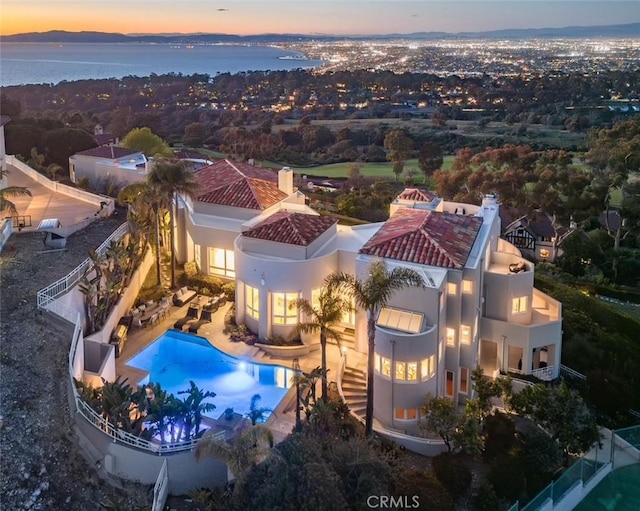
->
148, 159, 197, 288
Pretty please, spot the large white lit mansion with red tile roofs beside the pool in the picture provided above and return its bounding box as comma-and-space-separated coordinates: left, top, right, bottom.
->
178, 175, 562, 431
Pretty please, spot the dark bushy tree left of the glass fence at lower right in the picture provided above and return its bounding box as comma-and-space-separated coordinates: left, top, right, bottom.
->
511, 383, 600, 463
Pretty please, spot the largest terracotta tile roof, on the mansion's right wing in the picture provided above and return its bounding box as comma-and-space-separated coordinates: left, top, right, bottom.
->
360, 209, 482, 269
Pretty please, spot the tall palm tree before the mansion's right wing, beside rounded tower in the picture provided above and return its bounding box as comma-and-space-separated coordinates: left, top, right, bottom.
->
325, 259, 424, 436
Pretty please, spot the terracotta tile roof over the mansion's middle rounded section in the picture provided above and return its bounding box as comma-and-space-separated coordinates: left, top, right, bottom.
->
242, 211, 338, 247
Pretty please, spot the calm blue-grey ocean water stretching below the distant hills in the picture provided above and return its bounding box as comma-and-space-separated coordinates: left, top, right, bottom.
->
0, 43, 321, 86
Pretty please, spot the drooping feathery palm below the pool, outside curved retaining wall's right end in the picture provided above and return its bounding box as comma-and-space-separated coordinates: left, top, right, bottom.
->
195, 424, 273, 492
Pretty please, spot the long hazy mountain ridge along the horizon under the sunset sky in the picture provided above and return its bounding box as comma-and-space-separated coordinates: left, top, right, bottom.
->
0, 23, 640, 44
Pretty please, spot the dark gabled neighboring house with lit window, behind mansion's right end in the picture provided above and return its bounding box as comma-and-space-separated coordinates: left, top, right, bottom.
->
500, 210, 575, 262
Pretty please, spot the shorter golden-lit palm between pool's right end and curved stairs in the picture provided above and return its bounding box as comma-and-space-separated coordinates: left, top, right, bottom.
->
291, 288, 351, 401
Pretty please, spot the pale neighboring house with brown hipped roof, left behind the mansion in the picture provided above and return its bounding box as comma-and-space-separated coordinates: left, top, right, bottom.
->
69, 145, 150, 186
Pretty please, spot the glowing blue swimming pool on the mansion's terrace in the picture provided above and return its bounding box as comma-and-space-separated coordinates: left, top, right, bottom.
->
127, 330, 294, 418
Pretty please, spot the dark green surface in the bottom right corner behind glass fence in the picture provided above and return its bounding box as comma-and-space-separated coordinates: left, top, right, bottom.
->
574, 463, 640, 511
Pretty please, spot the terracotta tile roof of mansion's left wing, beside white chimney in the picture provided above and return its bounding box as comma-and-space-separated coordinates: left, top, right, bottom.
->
193, 160, 287, 210
